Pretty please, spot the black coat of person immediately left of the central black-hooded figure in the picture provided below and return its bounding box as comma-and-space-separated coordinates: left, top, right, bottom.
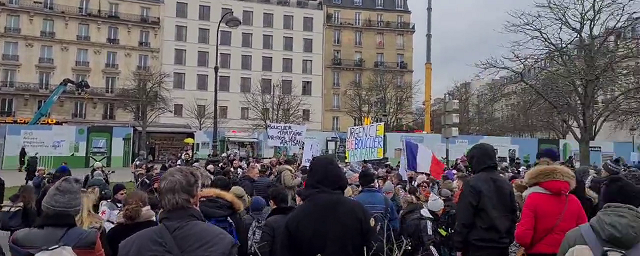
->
258, 206, 296, 256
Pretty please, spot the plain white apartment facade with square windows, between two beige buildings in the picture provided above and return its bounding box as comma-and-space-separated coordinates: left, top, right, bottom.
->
160, 0, 324, 130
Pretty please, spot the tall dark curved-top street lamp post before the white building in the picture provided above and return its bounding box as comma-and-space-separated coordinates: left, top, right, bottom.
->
211, 12, 242, 154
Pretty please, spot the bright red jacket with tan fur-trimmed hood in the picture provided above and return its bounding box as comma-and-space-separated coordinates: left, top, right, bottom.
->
515, 164, 587, 254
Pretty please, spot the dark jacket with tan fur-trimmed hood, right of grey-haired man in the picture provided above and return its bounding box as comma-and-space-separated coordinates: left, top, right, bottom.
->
199, 188, 249, 256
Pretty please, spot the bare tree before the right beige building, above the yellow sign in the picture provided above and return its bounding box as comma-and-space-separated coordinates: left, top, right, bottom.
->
343, 69, 418, 130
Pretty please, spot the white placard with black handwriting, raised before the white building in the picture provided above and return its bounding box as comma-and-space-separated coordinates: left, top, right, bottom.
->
267, 124, 307, 147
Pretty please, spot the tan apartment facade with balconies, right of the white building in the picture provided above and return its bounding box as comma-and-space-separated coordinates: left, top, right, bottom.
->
323, 0, 415, 132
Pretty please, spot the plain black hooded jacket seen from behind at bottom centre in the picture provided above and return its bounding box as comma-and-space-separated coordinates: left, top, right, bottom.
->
279, 156, 374, 256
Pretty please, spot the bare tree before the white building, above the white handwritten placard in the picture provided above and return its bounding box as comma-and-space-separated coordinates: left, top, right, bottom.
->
243, 79, 311, 129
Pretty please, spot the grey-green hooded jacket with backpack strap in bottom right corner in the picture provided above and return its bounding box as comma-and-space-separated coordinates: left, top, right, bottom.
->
558, 203, 640, 256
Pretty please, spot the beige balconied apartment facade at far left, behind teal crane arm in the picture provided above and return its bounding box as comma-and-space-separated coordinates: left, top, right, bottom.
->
0, 0, 162, 124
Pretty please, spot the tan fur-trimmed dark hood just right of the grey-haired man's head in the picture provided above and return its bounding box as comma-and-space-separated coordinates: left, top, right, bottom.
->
199, 188, 244, 219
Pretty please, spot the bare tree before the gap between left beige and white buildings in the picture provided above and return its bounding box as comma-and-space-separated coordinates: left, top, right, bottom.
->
118, 67, 172, 150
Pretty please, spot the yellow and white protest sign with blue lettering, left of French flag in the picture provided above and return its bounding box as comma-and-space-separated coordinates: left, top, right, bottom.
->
346, 123, 384, 162
